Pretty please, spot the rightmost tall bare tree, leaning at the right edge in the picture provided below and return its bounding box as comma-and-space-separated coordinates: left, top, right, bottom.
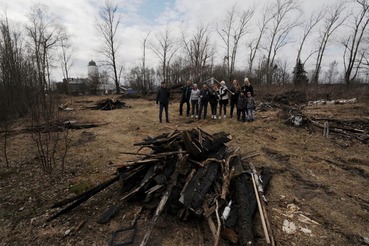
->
342, 0, 369, 84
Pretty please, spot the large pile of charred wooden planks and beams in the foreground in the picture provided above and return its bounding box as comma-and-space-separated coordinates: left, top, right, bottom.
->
49, 128, 274, 245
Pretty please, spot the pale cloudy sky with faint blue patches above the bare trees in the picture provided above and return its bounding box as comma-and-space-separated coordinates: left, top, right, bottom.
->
0, 0, 343, 80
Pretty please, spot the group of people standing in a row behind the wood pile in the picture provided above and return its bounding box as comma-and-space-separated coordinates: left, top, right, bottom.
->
156, 78, 256, 122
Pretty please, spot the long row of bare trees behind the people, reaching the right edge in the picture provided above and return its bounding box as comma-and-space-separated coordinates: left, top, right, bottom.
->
126, 0, 369, 89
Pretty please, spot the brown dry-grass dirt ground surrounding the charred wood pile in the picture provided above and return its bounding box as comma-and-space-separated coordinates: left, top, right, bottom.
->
0, 93, 369, 246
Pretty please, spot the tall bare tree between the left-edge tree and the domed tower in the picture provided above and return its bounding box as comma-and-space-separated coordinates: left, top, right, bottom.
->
26, 5, 70, 174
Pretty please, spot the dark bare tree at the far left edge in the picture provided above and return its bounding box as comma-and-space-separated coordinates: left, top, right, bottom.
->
0, 13, 30, 168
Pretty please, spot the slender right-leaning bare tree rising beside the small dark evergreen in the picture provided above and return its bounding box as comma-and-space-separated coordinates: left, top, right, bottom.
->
293, 11, 324, 84
